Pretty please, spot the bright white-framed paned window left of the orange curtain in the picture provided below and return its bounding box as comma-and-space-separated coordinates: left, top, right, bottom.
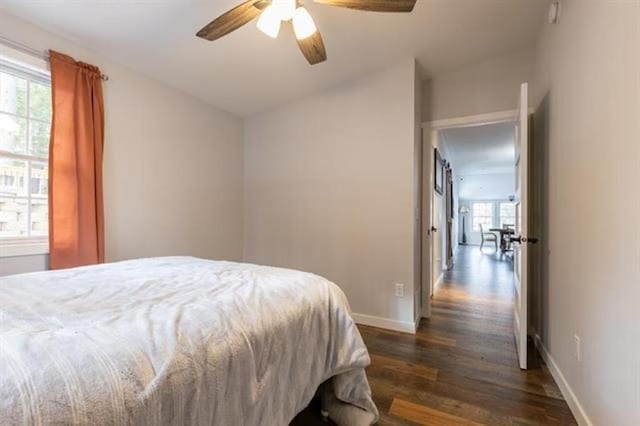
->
0, 58, 51, 242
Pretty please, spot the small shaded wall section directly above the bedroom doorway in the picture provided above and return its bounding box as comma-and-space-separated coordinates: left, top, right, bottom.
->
422, 48, 535, 121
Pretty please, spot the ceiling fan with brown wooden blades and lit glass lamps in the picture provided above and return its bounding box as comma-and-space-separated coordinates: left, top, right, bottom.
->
197, 0, 417, 65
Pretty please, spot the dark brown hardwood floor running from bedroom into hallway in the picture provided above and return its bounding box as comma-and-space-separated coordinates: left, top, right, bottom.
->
293, 246, 576, 425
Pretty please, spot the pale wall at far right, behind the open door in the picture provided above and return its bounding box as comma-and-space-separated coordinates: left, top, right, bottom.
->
534, 0, 640, 426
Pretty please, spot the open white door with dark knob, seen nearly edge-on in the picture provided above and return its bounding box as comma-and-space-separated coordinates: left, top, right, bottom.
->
513, 83, 529, 370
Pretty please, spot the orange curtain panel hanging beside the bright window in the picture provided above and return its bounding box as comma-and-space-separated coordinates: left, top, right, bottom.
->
49, 51, 104, 269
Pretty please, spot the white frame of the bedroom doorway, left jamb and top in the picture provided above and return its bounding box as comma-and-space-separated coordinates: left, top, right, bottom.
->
418, 108, 534, 318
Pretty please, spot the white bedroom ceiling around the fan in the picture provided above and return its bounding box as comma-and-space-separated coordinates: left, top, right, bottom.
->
0, 0, 548, 115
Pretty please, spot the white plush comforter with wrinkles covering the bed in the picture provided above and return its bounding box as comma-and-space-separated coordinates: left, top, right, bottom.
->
0, 257, 377, 426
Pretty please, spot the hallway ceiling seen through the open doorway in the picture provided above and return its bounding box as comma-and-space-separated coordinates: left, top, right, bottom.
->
441, 123, 515, 200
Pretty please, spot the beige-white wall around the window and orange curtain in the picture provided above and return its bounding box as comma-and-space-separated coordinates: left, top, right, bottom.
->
0, 12, 243, 275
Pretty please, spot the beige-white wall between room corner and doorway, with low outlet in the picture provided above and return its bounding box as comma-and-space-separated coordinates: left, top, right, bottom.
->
244, 60, 416, 325
